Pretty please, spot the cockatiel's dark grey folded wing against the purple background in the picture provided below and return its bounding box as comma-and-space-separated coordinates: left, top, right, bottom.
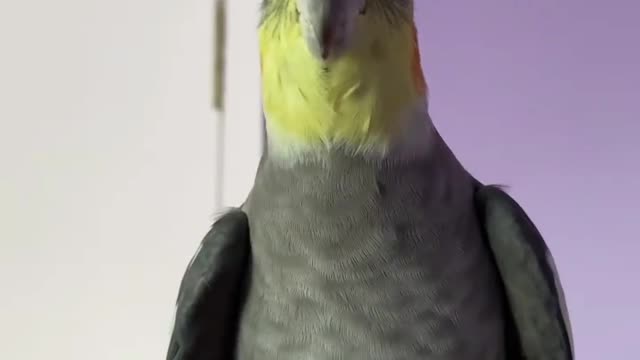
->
475, 184, 574, 360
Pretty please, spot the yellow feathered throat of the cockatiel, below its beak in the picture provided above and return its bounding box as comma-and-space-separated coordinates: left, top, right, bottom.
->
260, 17, 427, 162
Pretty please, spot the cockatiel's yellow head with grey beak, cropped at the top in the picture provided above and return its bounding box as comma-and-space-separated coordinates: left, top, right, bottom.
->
259, 0, 426, 158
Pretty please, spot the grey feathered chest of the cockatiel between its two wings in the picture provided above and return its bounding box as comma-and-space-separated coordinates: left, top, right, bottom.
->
239, 153, 504, 360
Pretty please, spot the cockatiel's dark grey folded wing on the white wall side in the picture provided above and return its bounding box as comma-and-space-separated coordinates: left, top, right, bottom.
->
167, 210, 251, 360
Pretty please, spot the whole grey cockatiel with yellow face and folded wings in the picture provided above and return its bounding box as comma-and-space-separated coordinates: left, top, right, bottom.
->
167, 0, 574, 360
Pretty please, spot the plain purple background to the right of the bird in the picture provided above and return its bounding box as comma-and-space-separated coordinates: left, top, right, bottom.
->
416, 0, 640, 360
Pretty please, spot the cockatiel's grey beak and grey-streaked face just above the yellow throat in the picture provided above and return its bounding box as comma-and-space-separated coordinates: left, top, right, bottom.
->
263, 0, 413, 62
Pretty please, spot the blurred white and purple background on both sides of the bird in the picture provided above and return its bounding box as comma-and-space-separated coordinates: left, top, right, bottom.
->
0, 0, 640, 360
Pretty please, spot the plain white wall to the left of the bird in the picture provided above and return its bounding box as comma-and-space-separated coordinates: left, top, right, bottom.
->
0, 0, 260, 360
